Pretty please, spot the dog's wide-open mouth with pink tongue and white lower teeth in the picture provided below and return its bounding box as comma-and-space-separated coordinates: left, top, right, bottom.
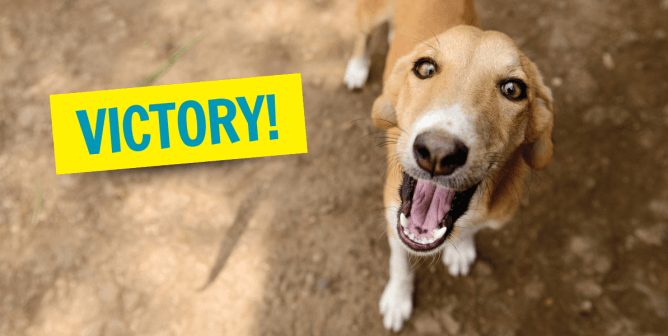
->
397, 173, 478, 252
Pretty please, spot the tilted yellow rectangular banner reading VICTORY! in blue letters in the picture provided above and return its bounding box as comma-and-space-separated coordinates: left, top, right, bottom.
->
50, 74, 307, 174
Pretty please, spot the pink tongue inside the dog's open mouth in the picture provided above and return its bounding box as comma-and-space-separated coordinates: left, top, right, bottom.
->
408, 180, 455, 238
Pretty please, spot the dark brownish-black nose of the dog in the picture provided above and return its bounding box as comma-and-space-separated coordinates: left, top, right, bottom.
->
413, 131, 469, 176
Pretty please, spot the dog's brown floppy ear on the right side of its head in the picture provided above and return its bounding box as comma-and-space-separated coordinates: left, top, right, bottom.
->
522, 63, 554, 170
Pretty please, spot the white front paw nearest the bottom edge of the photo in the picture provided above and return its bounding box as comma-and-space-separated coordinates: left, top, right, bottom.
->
380, 281, 413, 331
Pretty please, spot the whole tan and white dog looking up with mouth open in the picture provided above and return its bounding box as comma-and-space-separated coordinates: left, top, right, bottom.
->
344, 0, 553, 331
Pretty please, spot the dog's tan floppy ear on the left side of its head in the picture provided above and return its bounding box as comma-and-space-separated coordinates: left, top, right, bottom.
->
371, 56, 408, 130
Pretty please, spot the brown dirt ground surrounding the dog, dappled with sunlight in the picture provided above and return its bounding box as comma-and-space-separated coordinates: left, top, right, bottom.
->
0, 0, 668, 336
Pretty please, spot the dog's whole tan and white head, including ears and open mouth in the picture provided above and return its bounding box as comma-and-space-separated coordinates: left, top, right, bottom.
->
373, 26, 553, 254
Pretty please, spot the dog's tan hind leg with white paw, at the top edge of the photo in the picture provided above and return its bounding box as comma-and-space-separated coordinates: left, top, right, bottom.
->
343, 0, 392, 90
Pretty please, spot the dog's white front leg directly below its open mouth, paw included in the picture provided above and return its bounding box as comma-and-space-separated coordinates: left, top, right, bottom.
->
380, 232, 414, 331
